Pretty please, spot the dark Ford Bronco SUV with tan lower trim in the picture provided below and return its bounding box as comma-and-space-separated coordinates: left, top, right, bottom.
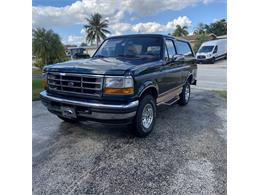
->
40, 34, 197, 137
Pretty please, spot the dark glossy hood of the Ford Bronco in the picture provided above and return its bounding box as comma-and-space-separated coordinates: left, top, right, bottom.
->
44, 58, 159, 75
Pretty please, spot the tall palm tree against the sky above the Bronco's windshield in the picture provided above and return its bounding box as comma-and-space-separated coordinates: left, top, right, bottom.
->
84, 13, 110, 46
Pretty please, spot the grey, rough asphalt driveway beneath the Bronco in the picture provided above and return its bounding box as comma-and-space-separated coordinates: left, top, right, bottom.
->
32, 85, 227, 194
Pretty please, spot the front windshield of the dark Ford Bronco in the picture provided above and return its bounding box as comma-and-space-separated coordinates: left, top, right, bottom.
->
93, 37, 162, 59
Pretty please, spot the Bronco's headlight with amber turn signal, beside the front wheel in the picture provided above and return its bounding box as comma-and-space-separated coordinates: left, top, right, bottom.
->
104, 76, 134, 95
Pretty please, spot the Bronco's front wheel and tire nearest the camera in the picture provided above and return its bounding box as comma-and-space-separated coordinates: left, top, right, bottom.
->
133, 95, 156, 137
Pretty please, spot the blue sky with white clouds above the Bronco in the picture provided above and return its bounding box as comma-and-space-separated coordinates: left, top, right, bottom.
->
32, 0, 227, 45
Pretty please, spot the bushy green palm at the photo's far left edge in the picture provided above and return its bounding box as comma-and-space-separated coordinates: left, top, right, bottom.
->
32, 28, 65, 68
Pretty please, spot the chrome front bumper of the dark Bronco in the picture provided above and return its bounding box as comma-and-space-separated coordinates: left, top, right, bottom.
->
40, 91, 139, 122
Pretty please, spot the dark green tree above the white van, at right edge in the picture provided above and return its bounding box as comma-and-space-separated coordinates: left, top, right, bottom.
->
207, 19, 227, 36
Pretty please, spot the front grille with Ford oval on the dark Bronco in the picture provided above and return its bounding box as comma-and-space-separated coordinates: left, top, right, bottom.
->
48, 72, 103, 97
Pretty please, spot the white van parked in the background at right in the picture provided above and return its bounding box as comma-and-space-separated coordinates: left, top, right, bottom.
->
196, 39, 227, 64
